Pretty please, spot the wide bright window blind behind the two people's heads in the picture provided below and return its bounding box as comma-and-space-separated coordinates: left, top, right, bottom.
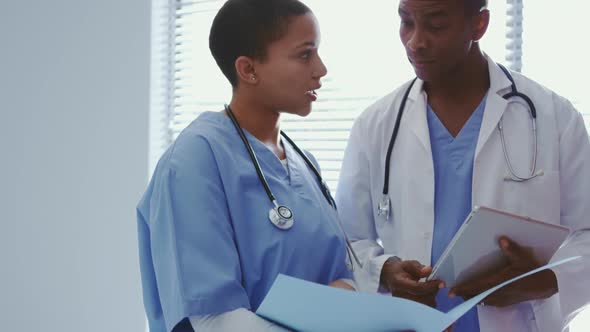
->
167, 0, 522, 191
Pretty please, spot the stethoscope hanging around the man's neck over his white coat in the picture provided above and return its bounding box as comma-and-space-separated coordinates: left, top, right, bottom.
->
377, 64, 544, 220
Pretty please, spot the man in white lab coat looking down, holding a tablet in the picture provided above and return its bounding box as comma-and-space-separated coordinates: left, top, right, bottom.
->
336, 0, 590, 332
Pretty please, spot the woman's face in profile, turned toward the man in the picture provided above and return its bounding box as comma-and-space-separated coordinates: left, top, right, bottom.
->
255, 13, 327, 116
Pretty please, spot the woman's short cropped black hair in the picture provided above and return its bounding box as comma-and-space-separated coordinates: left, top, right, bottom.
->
209, 0, 311, 88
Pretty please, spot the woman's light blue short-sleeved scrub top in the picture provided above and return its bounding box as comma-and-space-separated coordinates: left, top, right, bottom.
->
137, 112, 351, 332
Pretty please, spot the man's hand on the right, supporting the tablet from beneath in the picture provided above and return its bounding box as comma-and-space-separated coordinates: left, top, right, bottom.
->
449, 236, 558, 307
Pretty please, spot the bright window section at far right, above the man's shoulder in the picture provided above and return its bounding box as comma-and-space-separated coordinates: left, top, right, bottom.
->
522, 0, 590, 129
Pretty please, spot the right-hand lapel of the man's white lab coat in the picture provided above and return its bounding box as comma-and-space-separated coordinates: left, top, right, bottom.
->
474, 57, 510, 160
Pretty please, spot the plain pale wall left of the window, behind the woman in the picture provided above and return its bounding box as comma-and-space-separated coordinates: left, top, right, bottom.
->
0, 0, 150, 332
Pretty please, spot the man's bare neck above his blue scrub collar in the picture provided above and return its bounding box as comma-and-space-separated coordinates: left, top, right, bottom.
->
424, 44, 490, 100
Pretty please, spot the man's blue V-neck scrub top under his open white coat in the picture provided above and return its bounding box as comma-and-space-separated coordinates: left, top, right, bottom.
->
428, 97, 486, 332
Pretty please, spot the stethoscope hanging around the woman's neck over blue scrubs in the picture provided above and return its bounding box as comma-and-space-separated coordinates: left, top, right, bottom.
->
225, 105, 362, 270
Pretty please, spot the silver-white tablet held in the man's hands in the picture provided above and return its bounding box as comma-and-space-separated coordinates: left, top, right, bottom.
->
428, 206, 570, 287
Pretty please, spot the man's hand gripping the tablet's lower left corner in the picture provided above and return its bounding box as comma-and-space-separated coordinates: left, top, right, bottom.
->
380, 257, 444, 307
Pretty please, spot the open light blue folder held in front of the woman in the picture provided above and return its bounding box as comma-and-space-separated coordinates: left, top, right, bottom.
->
256, 256, 581, 332
